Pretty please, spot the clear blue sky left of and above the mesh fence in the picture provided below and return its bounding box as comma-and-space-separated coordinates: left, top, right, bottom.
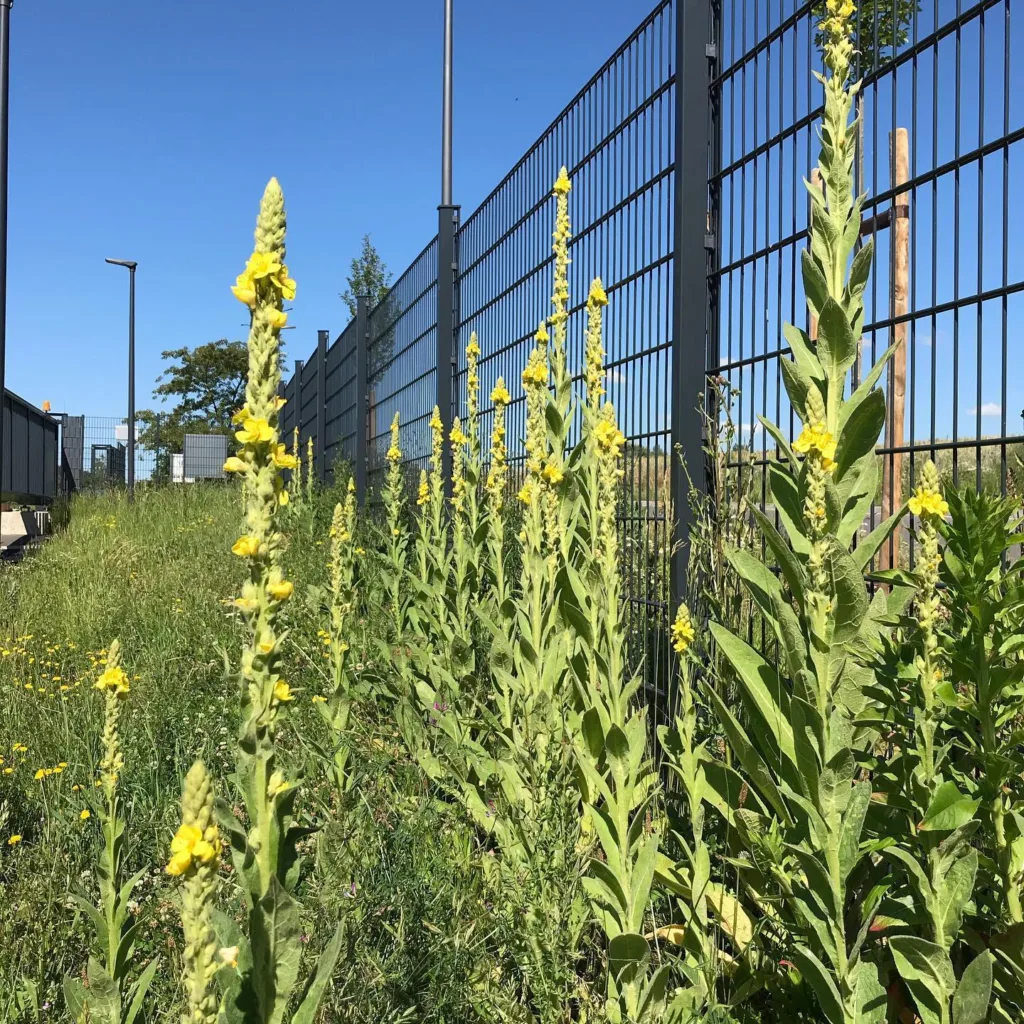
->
7, 0, 652, 416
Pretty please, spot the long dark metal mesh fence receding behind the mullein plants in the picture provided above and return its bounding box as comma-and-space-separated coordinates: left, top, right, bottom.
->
282, 0, 1024, 706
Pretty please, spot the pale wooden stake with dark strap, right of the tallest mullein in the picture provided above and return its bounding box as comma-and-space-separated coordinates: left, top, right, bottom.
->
881, 128, 910, 568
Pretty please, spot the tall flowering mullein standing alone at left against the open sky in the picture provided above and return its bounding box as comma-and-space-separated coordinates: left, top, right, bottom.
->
217, 178, 342, 1024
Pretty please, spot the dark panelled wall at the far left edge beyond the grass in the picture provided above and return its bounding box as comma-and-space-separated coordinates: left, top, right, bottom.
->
0, 390, 57, 505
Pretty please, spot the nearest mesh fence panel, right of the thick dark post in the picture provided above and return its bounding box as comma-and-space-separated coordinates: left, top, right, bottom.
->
709, 0, 1024, 566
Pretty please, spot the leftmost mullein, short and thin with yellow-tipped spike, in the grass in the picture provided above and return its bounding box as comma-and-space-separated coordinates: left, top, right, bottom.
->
63, 640, 159, 1024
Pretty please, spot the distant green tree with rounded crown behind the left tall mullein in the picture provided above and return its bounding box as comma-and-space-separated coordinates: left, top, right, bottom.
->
137, 338, 249, 479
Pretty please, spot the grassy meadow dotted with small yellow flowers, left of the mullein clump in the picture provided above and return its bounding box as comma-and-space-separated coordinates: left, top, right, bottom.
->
0, 485, 486, 1024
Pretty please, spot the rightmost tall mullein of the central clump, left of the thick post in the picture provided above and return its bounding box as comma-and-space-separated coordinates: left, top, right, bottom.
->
556, 276, 669, 1024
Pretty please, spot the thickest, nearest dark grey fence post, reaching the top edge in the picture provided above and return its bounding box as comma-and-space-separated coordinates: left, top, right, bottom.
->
670, 0, 715, 613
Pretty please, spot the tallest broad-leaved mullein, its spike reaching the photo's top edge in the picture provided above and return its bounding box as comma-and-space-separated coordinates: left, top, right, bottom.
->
667, 0, 937, 1024
